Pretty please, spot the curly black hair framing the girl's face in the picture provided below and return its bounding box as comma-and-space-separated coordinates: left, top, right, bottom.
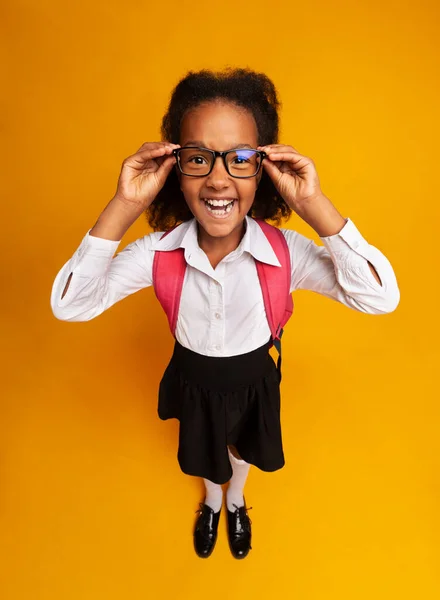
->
146, 67, 292, 231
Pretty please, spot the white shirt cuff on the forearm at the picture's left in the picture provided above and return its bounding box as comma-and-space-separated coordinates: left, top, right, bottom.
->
70, 229, 121, 277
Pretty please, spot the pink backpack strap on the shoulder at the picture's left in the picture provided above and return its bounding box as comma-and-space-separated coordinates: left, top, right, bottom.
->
153, 225, 186, 336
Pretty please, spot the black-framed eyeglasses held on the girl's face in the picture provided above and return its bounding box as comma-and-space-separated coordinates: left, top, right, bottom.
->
173, 146, 267, 179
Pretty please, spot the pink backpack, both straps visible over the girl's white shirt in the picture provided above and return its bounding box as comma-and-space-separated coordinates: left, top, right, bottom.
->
153, 219, 293, 369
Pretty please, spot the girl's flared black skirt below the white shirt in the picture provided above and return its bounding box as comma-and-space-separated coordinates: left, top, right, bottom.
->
158, 341, 284, 484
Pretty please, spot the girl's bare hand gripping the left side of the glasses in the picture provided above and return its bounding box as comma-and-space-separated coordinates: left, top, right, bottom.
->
115, 142, 180, 211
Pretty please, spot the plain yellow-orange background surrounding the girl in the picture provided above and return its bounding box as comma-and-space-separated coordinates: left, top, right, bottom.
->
0, 0, 440, 600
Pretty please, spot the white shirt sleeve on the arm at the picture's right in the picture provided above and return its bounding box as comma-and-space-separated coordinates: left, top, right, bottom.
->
282, 218, 400, 314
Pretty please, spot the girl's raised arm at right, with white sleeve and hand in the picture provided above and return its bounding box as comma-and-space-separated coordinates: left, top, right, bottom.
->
258, 144, 400, 314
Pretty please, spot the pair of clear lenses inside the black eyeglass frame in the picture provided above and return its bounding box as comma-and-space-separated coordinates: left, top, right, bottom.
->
179, 148, 261, 177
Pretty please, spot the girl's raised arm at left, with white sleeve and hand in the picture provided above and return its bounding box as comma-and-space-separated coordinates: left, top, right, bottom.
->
51, 141, 183, 321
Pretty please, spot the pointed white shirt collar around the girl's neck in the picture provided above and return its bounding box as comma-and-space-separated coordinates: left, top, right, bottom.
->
150, 215, 281, 267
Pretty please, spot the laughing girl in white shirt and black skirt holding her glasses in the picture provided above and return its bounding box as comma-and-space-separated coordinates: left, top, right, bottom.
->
51, 69, 400, 558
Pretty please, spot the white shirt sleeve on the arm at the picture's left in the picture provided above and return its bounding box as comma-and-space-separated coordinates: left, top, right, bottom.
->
50, 229, 158, 321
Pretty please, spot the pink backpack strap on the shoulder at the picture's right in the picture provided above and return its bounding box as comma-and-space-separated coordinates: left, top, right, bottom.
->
255, 219, 293, 377
